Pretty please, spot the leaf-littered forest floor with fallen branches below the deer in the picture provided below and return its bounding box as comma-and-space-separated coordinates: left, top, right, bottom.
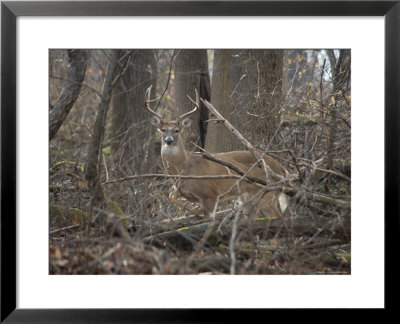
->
49, 163, 351, 274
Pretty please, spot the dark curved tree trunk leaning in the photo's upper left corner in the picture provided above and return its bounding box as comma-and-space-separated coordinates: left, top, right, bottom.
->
49, 50, 88, 140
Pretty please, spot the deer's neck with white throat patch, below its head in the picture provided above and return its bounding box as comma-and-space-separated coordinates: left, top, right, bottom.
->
161, 138, 188, 174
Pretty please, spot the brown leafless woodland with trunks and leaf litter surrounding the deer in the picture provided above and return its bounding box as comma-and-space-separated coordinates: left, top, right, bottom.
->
49, 49, 351, 274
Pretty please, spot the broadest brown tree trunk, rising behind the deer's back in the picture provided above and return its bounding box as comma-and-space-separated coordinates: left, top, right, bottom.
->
206, 50, 283, 152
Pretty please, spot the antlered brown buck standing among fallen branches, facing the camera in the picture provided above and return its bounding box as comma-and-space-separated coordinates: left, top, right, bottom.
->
145, 87, 288, 217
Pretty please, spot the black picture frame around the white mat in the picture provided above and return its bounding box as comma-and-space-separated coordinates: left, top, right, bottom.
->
0, 0, 400, 323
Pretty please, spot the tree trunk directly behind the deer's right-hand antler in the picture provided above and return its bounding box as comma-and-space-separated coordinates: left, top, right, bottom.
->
173, 49, 210, 150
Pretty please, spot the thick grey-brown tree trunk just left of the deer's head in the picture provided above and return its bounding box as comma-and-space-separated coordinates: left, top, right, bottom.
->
111, 50, 158, 174
